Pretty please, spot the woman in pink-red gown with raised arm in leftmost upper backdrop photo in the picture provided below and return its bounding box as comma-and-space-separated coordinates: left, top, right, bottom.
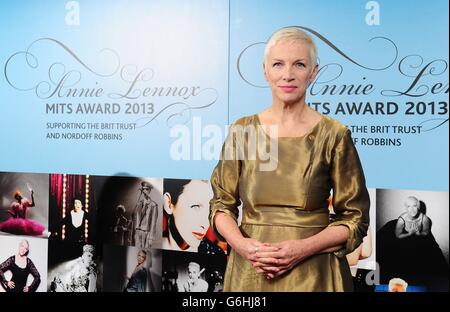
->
0, 190, 45, 236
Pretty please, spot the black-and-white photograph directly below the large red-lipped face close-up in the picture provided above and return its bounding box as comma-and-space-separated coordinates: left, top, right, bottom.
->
162, 250, 227, 292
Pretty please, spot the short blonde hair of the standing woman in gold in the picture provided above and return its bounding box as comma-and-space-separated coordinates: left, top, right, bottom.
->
264, 27, 317, 69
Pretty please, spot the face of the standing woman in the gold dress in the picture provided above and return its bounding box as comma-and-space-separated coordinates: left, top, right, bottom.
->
264, 40, 317, 104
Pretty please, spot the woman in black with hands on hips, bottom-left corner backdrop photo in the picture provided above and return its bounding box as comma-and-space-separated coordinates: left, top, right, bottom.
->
0, 240, 41, 292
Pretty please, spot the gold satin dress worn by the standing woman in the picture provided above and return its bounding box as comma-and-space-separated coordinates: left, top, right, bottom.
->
209, 115, 370, 292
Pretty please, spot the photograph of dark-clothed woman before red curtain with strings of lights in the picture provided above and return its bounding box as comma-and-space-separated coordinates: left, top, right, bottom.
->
49, 174, 97, 244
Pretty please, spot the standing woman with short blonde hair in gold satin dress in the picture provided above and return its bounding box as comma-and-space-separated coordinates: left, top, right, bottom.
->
210, 27, 369, 291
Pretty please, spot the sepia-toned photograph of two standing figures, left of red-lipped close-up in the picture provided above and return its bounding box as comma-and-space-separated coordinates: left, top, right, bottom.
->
95, 176, 162, 249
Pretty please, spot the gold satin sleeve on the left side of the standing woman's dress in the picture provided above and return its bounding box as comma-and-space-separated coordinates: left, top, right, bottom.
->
209, 125, 241, 241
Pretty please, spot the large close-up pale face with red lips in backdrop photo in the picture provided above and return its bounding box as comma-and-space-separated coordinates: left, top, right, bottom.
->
172, 180, 213, 248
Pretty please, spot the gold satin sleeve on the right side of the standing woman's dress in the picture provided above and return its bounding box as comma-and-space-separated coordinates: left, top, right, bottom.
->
329, 129, 370, 257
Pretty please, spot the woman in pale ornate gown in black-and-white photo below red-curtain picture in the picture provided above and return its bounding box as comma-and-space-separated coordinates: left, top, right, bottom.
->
50, 245, 97, 292
